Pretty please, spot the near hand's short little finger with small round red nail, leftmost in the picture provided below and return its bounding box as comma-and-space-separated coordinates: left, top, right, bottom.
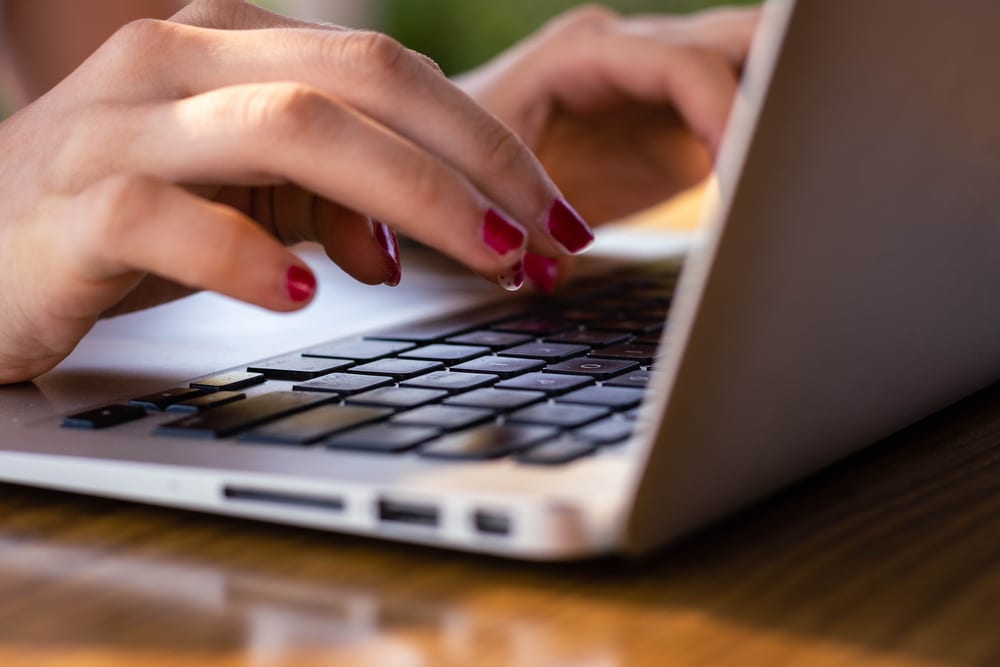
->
68, 176, 316, 311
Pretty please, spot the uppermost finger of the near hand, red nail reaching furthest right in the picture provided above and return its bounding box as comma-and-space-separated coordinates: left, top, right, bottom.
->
109, 19, 592, 254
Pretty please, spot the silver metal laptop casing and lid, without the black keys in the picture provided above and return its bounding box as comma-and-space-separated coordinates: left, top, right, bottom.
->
0, 0, 1000, 560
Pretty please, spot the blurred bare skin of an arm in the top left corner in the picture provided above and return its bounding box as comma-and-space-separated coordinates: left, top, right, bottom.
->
0, 0, 185, 104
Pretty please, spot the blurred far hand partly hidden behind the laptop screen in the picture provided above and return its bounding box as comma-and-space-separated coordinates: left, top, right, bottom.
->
458, 6, 759, 291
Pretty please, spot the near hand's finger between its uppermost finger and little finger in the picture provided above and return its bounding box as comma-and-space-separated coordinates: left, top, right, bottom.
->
130, 83, 526, 282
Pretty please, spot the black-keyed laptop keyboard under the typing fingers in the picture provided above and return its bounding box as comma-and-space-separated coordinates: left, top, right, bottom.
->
62, 266, 677, 465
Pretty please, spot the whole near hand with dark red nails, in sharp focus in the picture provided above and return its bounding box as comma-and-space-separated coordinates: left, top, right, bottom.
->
0, 0, 592, 383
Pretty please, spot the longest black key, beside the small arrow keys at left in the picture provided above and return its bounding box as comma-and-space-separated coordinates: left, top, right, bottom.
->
155, 391, 336, 438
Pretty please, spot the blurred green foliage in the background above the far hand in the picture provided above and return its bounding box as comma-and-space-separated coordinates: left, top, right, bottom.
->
380, 0, 750, 74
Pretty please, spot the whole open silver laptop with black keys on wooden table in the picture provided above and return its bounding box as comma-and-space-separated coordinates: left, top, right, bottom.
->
0, 0, 1000, 560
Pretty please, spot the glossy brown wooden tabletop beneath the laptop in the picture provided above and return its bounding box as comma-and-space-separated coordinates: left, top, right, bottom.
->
0, 387, 1000, 665
